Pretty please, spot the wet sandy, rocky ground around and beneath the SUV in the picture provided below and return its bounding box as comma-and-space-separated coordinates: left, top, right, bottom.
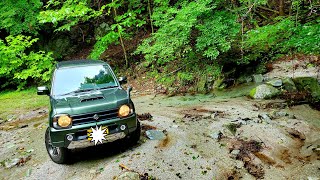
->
0, 90, 320, 179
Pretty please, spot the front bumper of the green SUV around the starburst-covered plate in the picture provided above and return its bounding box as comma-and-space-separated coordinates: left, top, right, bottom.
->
50, 114, 137, 148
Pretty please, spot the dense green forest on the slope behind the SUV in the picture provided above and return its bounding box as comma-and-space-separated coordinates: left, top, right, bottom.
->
0, 0, 320, 92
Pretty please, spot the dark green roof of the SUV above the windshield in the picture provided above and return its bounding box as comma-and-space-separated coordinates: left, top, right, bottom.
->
56, 59, 108, 69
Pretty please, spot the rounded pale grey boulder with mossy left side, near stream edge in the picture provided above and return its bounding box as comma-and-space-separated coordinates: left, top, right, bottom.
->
249, 84, 280, 99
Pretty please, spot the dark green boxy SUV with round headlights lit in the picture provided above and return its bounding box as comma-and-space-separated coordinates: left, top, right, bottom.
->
37, 60, 141, 164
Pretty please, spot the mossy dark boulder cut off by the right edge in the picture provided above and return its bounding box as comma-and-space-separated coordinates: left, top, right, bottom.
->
293, 77, 320, 102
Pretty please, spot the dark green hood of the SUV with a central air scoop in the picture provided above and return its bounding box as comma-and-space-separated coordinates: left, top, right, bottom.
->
51, 88, 128, 115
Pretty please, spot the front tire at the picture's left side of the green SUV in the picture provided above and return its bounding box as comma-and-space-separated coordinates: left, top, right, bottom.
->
45, 128, 68, 164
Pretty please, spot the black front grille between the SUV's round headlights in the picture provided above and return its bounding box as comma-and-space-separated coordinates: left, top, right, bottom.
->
71, 109, 118, 125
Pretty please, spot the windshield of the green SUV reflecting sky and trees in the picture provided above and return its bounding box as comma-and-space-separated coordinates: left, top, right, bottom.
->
52, 65, 118, 96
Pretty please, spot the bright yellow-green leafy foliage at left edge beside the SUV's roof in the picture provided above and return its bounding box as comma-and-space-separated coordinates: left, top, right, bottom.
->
0, 35, 53, 88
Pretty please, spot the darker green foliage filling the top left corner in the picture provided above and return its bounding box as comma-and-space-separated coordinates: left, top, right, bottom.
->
0, 0, 42, 35
